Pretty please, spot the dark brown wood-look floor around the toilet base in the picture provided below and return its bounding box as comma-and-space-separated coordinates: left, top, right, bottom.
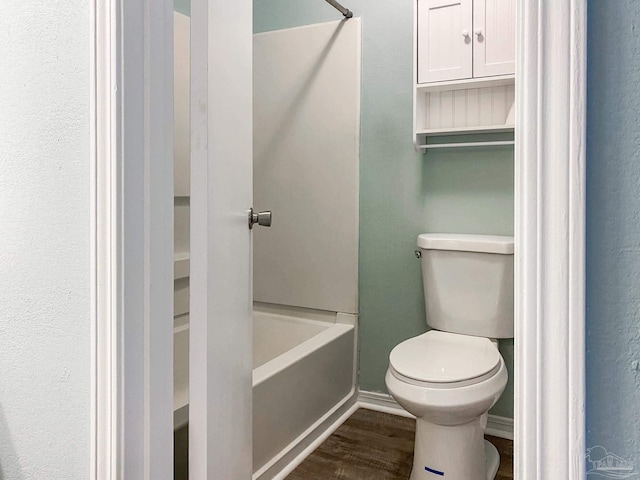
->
286, 408, 513, 480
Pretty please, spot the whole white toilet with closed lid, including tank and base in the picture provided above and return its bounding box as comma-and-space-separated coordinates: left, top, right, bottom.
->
385, 234, 513, 480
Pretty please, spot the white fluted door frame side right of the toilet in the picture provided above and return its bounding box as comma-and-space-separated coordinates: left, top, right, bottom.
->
514, 0, 587, 480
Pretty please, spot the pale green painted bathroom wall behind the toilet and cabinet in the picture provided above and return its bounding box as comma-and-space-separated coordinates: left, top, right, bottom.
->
254, 0, 513, 417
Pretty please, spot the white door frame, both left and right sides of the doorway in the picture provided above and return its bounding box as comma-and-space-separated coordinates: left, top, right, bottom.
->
91, 0, 587, 480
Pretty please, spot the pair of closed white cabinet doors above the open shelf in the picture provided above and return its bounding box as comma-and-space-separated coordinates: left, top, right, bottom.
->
416, 0, 516, 83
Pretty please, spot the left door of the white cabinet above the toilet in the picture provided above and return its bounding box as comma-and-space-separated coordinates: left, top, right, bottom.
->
417, 0, 473, 83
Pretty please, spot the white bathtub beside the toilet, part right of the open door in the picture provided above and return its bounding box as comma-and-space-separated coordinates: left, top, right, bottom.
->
253, 311, 355, 480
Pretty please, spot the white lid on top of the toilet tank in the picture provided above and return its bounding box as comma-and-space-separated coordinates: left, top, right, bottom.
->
418, 233, 513, 255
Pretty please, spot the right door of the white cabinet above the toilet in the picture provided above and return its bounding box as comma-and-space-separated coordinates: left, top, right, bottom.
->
473, 0, 516, 77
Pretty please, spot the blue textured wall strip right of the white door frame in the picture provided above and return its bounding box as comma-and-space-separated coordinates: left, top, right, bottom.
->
586, 0, 640, 468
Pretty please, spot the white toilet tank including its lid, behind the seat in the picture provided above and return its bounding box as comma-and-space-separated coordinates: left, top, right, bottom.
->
418, 233, 513, 338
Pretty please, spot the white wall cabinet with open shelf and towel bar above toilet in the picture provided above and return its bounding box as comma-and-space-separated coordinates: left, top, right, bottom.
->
414, 0, 516, 150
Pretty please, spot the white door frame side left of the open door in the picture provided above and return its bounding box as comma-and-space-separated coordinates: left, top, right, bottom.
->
90, 0, 173, 480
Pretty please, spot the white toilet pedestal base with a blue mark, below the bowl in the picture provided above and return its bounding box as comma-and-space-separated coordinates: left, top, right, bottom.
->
410, 418, 500, 480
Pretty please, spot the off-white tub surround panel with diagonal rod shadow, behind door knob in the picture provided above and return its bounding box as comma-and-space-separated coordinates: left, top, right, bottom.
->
253, 18, 360, 314
